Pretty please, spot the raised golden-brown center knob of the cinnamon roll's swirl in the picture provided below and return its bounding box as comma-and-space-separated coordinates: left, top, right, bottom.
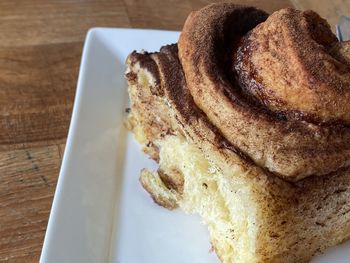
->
234, 8, 350, 125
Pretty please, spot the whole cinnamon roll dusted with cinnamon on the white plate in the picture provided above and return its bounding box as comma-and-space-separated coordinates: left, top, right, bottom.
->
126, 3, 350, 262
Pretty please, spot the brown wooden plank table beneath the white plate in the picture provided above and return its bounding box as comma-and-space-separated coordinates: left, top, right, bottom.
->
0, 0, 350, 262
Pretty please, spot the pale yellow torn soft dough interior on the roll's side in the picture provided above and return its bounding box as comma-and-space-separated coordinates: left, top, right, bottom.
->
152, 135, 257, 262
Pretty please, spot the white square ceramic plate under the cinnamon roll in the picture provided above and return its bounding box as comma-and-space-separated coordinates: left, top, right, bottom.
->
40, 28, 350, 263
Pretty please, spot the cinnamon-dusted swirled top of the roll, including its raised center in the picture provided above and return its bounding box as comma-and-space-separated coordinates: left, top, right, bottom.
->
178, 3, 350, 181
